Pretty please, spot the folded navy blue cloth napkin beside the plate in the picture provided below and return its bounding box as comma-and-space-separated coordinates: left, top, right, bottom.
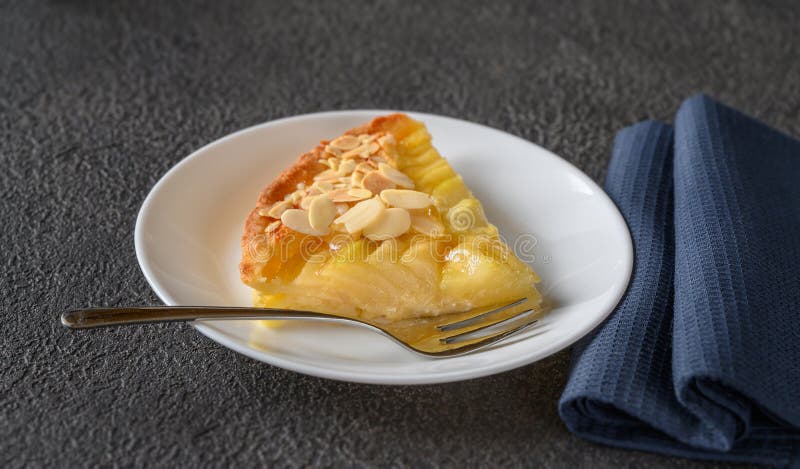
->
559, 95, 800, 467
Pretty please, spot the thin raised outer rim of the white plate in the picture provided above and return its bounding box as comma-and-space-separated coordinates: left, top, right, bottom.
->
134, 109, 634, 385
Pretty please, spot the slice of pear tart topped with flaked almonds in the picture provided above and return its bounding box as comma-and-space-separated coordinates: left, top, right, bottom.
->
240, 114, 541, 321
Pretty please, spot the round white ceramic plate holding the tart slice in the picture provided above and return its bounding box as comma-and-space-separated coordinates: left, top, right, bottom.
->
135, 111, 633, 384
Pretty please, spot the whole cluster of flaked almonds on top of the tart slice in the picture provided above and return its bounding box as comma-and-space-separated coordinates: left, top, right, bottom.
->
270, 134, 438, 241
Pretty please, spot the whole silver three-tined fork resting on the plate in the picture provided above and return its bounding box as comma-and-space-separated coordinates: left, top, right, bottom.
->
61, 298, 539, 358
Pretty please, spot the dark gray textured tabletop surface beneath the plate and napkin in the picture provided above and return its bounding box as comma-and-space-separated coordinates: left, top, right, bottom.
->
0, 0, 800, 467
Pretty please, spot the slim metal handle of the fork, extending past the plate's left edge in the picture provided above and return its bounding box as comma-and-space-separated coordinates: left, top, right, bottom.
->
61, 306, 328, 329
